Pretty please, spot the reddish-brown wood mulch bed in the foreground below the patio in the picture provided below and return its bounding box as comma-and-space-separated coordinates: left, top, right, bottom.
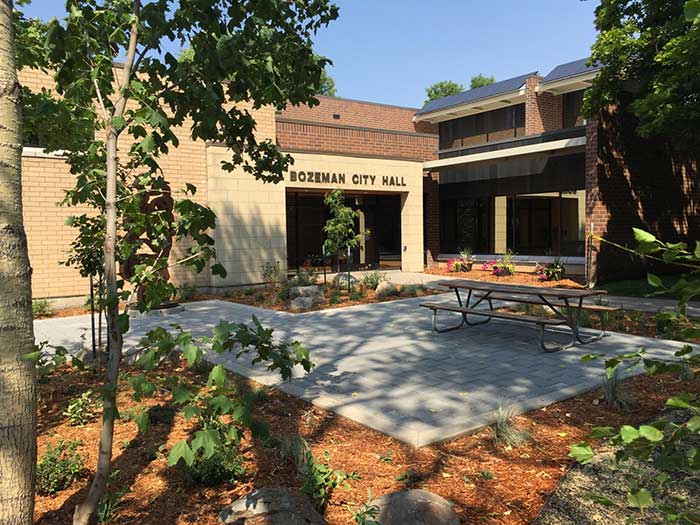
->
35, 356, 700, 525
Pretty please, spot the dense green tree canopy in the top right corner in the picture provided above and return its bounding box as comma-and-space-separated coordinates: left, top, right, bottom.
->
584, 0, 700, 147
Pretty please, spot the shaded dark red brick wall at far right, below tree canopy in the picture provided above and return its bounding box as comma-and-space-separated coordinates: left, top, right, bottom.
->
586, 104, 700, 281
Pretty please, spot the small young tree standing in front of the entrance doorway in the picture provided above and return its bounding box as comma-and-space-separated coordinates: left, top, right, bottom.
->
323, 189, 369, 272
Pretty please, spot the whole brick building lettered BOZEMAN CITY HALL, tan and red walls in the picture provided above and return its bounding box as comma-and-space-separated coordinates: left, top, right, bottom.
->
20, 59, 700, 298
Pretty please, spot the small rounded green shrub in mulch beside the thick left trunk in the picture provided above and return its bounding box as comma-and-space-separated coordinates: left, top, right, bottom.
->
36, 440, 85, 496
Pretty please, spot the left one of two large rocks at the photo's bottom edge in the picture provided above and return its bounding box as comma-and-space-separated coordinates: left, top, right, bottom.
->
219, 487, 326, 525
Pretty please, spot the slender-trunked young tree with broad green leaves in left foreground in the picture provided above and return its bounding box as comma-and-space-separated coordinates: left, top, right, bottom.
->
20, 0, 338, 525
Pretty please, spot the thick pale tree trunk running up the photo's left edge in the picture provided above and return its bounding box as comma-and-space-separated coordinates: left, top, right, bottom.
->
0, 0, 36, 525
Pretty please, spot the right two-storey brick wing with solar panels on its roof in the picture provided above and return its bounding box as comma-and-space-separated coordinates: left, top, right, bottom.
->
415, 59, 700, 281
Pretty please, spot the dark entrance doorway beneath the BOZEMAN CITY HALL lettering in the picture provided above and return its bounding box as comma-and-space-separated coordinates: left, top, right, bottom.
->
286, 190, 401, 270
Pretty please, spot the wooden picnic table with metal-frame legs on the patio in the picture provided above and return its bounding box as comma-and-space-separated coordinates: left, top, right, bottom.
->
421, 279, 619, 352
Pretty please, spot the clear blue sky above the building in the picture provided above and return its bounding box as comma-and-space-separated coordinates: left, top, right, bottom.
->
25, 0, 599, 107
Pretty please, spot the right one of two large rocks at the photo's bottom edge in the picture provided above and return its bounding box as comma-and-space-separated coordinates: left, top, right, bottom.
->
371, 489, 459, 525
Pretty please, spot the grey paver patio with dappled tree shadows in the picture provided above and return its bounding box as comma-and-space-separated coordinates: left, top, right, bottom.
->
35, 294, 682, 446
